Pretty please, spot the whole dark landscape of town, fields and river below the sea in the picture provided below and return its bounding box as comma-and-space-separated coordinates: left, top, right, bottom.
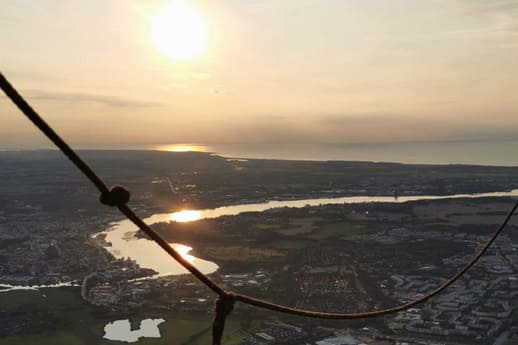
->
0, 147, 518, 345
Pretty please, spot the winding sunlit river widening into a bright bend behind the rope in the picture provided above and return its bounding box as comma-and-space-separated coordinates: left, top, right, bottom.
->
94, 189, 518, 275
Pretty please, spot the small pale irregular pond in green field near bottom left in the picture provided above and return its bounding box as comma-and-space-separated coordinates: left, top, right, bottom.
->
103, 319, 165, 343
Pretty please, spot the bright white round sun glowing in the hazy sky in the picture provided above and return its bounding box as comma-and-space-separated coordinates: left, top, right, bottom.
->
151, 0, 208, 61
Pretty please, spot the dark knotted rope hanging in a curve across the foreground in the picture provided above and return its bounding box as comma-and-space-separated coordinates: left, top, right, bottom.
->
0, 69, 518, 345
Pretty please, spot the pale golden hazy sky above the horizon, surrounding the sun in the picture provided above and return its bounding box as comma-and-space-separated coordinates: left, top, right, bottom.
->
0, 0, 518, 148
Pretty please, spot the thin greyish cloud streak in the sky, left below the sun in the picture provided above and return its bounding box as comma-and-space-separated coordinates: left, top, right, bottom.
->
26, 90, 161, 107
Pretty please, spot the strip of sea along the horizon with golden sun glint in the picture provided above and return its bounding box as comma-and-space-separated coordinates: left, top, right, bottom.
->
0, 139, 518, 166
